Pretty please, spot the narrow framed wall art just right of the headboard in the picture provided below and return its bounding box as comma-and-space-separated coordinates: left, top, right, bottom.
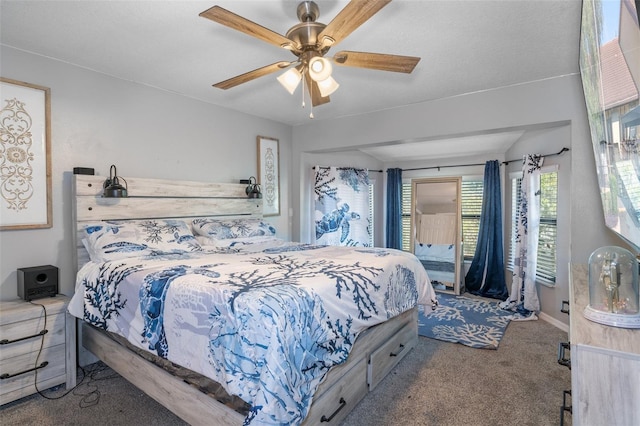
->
258, 136, 280, 216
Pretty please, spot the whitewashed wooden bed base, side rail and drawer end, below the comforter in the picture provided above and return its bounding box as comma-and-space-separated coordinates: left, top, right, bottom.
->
80, 308, 418, 426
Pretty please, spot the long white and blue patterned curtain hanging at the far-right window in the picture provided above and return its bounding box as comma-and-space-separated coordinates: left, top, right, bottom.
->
500, 154, 544, 321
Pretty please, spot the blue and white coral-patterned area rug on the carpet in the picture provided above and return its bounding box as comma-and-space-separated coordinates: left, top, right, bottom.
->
418, 293, 513, 349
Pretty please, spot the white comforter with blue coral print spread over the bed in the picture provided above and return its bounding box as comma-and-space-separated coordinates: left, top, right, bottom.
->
69, 241, 435, 424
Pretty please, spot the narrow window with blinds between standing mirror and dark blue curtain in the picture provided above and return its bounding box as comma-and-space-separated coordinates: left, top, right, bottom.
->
462, 180, 484, 260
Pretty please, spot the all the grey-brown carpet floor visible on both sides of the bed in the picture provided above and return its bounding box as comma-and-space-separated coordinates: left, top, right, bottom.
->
0, 321, 571, 426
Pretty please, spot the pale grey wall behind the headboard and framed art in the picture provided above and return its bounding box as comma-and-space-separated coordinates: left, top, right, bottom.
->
0, 46, 291, 300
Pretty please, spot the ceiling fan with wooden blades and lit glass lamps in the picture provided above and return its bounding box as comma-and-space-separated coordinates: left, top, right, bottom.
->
200, 0, 420, 111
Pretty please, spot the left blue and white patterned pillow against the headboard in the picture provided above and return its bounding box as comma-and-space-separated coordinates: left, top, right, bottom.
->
83, 219, 202, 262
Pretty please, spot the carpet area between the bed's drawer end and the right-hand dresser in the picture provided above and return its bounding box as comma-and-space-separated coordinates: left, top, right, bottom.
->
344, 320, 571, 426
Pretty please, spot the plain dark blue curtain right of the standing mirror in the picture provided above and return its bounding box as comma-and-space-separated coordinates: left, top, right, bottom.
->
465, 160, 509, 300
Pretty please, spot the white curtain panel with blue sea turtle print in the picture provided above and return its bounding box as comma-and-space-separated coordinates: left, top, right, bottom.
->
314, 166, 372, 247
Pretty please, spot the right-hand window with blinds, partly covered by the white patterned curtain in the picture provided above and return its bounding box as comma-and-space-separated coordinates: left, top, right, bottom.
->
508, 171, 558, 284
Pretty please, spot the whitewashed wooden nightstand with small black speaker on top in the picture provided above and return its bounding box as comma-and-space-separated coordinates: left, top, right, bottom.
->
0, 295, 76, 405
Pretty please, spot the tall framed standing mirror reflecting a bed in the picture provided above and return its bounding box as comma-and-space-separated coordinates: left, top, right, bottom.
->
411, 178, 462, 294
